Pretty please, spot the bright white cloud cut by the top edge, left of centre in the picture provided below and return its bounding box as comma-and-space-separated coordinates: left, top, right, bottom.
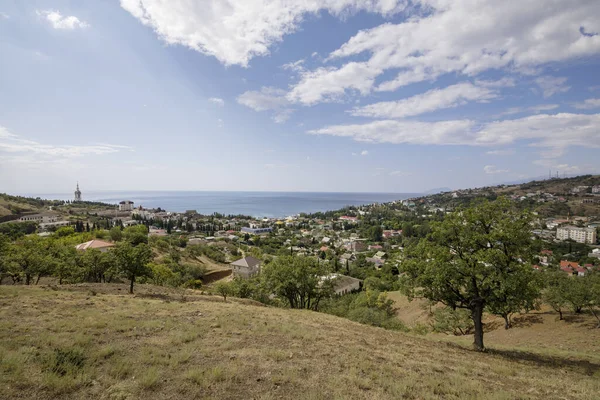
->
121, 0, 404, 66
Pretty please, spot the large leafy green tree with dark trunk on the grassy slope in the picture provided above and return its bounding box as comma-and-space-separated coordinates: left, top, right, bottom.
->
402, 199, 539, 351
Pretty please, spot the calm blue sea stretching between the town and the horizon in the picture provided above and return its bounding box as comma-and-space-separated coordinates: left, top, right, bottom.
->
25, 191, 419, 218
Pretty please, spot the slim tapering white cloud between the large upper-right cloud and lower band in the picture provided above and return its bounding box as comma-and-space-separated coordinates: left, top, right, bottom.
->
350, 82, 497, 118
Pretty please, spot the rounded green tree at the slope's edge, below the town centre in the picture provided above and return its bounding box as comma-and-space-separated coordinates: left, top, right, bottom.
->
261, 256, 334, 311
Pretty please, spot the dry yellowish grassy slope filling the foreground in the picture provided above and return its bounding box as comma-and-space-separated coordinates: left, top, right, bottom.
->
0, 284, 600, 399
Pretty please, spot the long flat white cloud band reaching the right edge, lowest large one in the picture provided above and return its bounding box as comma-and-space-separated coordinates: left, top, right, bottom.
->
307, 113, 600, 149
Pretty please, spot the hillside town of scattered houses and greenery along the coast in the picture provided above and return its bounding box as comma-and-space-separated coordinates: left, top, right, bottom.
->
5, 178, 600, 294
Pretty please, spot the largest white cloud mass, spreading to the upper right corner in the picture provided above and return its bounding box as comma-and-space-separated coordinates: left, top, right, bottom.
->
292, 0, 600, 104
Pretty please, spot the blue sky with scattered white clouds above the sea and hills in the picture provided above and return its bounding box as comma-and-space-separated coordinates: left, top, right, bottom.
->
0, 0, 600, 193
